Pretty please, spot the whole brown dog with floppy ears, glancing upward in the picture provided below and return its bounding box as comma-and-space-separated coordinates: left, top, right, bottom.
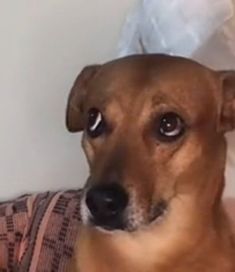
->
67, 55, 235, 272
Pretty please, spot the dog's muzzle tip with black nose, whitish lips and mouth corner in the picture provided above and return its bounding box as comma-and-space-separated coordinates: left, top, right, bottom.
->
81, 183, 168, 232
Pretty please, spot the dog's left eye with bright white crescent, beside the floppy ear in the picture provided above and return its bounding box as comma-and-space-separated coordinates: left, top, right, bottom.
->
87, 108, 106, 138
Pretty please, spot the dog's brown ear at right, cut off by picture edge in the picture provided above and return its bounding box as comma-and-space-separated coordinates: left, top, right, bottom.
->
219, 71, 235, 132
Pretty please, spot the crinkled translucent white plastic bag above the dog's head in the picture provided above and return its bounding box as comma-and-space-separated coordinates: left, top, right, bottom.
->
119, 0, 233, 57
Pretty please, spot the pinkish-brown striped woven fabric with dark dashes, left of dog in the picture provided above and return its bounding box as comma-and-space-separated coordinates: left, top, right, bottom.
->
0, 190, 81, 272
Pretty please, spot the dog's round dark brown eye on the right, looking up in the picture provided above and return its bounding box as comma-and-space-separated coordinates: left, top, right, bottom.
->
157, 112, 185, 141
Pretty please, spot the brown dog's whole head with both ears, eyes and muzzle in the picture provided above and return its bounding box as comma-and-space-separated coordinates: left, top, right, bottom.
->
67, 55, 235, 231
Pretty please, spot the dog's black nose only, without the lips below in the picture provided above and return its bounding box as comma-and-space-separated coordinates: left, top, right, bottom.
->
86, 184, 128, 219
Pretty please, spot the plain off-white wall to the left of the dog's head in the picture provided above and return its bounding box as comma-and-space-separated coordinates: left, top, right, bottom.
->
0, 0, 135, 199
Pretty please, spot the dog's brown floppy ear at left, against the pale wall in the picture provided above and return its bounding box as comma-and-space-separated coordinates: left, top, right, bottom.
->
66, 65, 100, 132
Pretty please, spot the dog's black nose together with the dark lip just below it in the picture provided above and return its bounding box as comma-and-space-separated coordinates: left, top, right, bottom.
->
86, 183, 128, 229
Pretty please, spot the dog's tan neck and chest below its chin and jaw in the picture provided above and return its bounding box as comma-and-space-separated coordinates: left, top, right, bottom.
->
79, 191, 235, 272
